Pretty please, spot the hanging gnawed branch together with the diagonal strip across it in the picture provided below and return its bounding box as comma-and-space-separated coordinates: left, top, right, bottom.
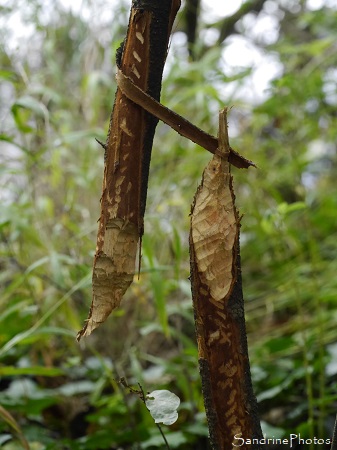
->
78, 0, 255, 339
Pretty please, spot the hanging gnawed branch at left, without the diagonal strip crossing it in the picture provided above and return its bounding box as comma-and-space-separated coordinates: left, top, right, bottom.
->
77, 0, 180, 340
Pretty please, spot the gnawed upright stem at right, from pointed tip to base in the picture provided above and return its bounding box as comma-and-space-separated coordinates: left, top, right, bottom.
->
190, 110, 262, 450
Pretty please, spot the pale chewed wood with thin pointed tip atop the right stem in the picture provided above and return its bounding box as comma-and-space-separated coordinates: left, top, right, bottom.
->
191, 110, 239, 301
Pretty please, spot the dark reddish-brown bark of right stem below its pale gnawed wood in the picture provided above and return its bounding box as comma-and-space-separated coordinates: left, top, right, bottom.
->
190, 236, 263, 450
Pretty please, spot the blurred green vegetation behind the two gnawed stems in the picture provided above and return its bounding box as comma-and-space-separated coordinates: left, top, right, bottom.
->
0, 0, 337, 450
